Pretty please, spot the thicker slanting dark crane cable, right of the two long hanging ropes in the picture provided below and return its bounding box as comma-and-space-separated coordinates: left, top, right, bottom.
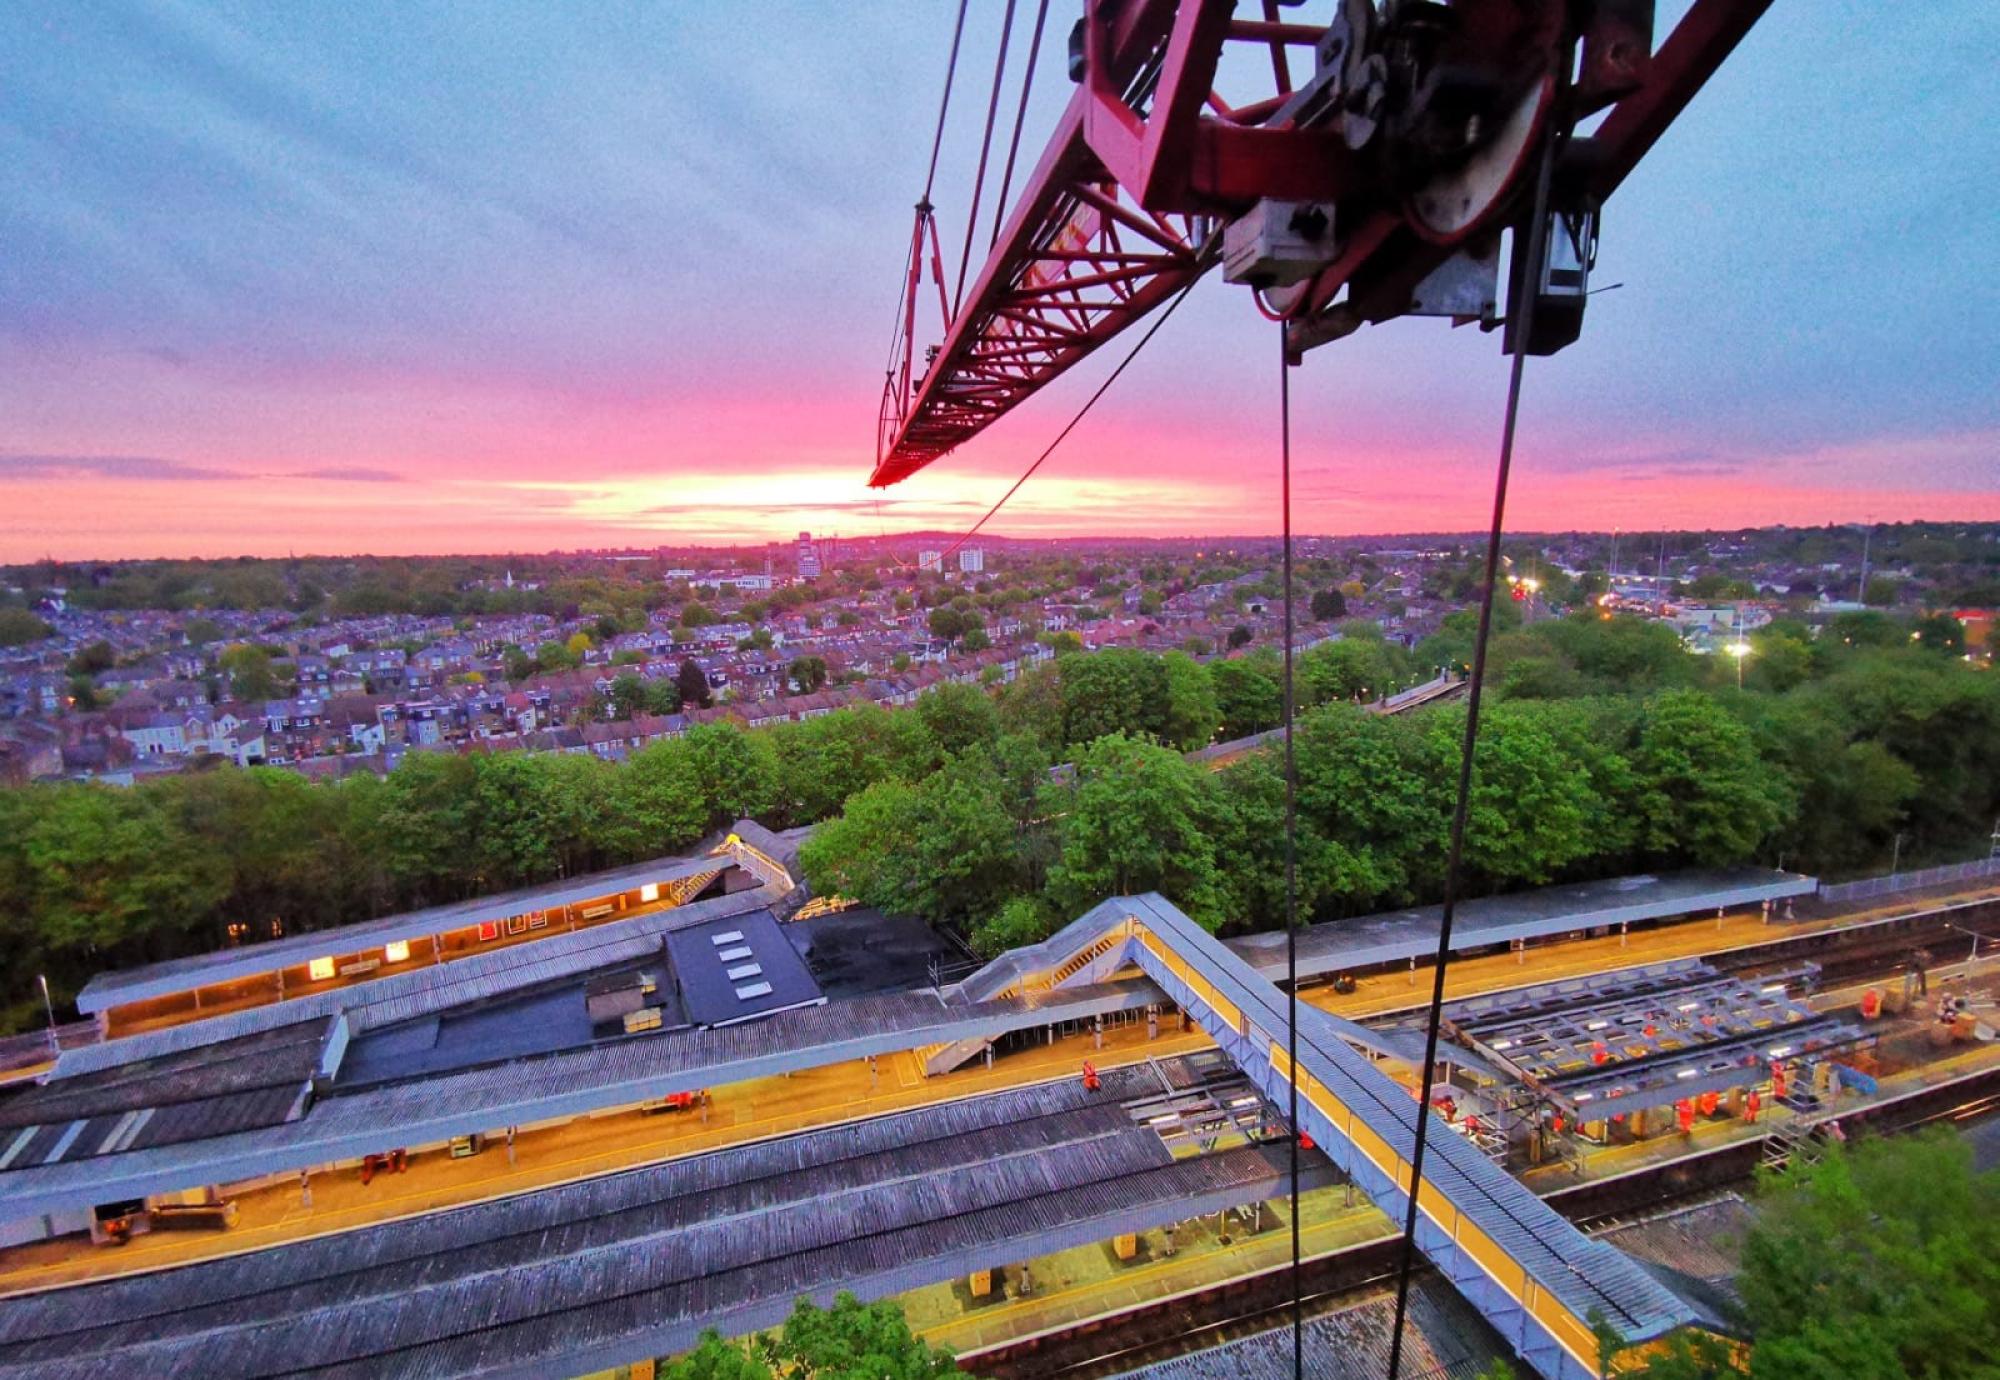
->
1388, 115, 1556, 1380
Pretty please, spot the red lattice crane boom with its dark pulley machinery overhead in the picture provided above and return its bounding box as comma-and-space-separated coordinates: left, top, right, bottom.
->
870, 0, 1770, 488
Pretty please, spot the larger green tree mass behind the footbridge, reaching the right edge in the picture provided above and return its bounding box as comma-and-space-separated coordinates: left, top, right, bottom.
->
802, 614, 2000, 952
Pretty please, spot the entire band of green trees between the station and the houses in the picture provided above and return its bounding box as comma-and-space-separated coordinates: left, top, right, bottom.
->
0, 618, 2000, 1024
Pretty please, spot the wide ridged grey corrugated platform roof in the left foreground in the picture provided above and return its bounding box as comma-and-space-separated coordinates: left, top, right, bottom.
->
0, 1070, 1324, 1380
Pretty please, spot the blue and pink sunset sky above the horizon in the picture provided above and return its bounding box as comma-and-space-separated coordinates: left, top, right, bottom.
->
0, 0, 2000, 560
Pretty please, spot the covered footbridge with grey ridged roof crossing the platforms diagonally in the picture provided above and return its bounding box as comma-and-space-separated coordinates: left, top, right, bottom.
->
964, 894, 1694, 1380
